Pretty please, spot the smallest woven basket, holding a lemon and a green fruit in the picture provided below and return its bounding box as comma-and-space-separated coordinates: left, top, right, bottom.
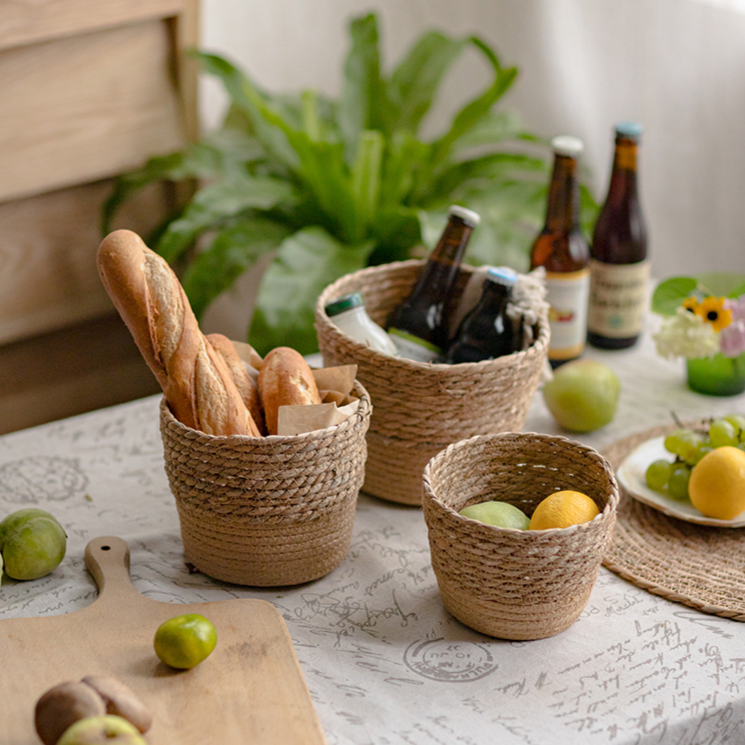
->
423, 432, 619, 640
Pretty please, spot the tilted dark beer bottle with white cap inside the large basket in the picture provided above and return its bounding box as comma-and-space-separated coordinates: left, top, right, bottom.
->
386, 206, 479, 362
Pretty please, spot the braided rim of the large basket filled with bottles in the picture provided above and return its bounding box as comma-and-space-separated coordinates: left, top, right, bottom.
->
316, 259, 549, 375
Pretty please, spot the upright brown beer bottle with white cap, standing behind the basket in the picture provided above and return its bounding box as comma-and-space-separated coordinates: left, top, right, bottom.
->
530, 136, 590, 367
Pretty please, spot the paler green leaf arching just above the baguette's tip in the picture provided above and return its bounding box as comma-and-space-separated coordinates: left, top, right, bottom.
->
156, 173, 292, 262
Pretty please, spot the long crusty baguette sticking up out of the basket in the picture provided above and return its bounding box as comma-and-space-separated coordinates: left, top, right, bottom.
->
96, 230, 261, 437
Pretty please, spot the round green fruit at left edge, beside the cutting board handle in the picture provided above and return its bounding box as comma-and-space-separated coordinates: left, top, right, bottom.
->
0, 507, 67, 580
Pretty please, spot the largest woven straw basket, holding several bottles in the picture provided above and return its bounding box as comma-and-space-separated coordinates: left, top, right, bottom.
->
316, 260, 549, 505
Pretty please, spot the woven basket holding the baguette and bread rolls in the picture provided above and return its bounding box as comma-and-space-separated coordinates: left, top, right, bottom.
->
160, 383, 371, 587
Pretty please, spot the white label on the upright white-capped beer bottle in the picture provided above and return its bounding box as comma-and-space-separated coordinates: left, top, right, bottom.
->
546, 269, 590, 360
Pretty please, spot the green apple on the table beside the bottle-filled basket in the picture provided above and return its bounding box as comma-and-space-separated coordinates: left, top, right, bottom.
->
543, 360, 621, 432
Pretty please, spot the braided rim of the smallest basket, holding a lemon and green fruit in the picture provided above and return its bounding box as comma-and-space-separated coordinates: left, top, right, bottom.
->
422, 432, 620, 541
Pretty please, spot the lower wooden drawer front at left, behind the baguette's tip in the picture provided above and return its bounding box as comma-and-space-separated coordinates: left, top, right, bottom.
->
0, 181, 171, 343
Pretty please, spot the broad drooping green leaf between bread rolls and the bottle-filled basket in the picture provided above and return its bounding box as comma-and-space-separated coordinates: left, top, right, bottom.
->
248, 227, 372, 354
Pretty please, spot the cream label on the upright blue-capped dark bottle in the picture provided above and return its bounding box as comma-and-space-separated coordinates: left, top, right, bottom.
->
587, 260, 650, 339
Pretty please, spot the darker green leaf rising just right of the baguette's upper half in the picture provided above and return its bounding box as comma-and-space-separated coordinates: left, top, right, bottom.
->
183, 217, 292, 318
